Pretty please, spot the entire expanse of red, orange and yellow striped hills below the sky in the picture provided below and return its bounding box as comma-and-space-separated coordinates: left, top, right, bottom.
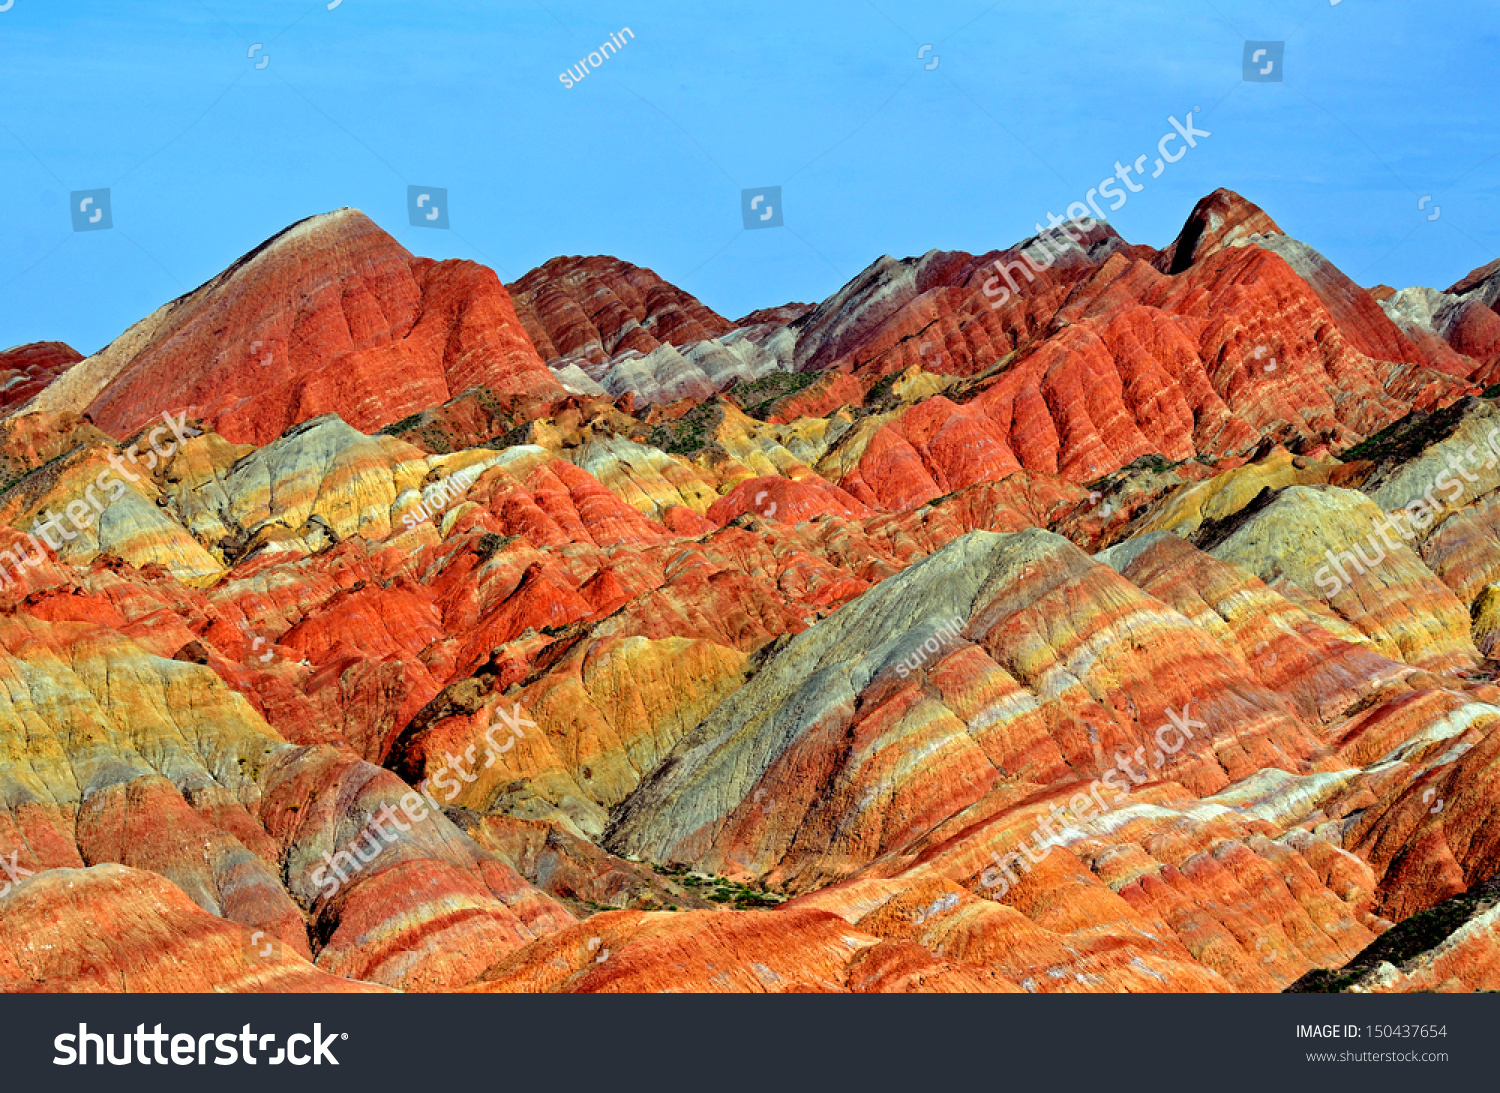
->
0, 190, 1500, 993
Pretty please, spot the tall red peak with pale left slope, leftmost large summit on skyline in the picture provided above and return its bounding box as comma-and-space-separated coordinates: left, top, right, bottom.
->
27, 208, 564, 444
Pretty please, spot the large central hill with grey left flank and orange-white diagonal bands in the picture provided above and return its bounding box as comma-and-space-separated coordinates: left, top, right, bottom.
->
609, 531, 1338, 889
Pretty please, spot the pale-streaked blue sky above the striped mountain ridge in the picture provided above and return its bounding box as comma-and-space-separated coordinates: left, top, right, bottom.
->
0, 0, 1500, 352
